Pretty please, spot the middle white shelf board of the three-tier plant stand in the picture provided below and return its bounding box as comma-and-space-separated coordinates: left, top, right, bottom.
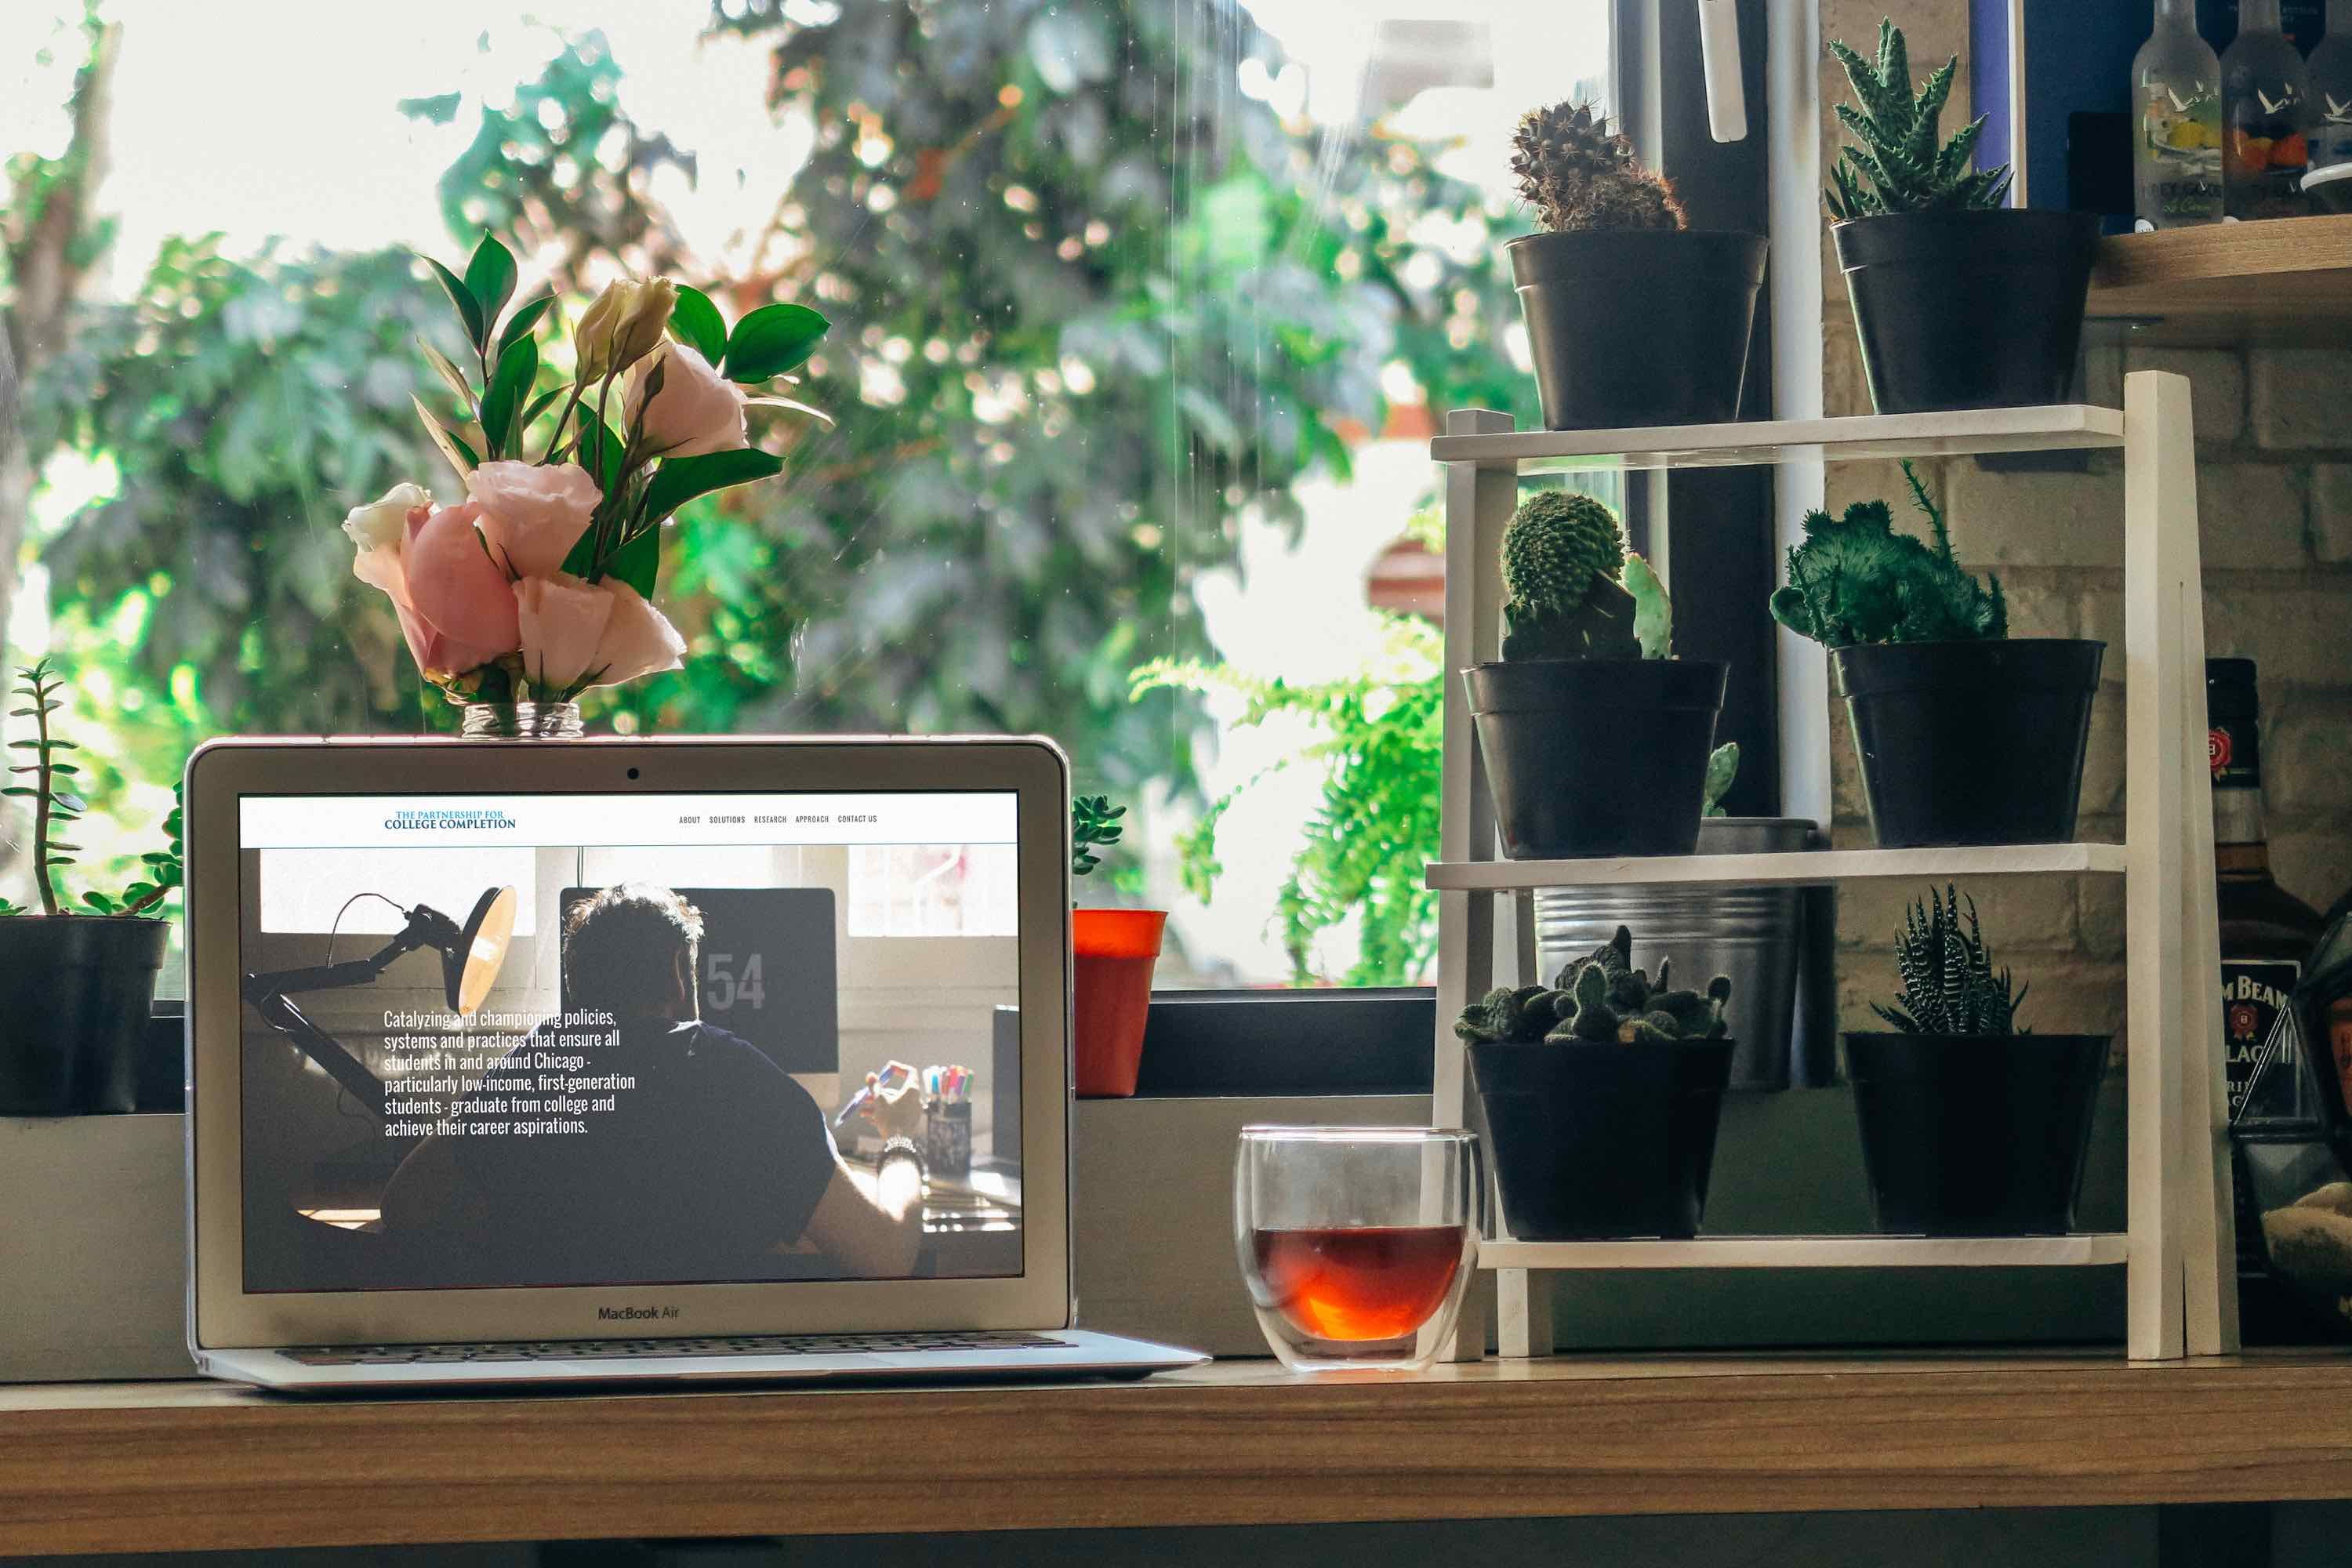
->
1428, 844, 2126, 893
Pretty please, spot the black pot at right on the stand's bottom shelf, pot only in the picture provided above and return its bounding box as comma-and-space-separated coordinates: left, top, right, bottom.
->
1846, 1034, 2107, 1236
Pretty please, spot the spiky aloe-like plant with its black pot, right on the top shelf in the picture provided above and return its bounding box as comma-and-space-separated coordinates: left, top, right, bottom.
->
1825, 21, 2098, 414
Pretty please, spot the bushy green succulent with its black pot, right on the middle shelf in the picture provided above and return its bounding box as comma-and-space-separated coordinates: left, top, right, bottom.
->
1771, 463, 2107, 848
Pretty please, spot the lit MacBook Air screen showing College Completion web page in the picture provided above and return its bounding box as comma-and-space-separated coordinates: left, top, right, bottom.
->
238, 789, 1021, 1293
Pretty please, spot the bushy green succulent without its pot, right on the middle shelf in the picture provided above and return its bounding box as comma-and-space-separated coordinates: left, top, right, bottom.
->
1771, 463, 2009, 649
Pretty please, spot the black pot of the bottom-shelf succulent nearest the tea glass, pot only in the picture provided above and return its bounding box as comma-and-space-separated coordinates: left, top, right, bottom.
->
1470, 1039, 1731, 1241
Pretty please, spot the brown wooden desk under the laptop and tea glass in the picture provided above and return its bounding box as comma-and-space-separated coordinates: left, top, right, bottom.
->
0, 1354, 2352, 1552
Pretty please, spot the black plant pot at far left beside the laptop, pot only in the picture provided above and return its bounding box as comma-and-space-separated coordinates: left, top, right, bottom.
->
0, 914, 172, 1116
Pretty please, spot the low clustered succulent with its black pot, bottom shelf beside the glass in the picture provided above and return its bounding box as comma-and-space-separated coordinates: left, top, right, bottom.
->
1454, 926, 1733, 1241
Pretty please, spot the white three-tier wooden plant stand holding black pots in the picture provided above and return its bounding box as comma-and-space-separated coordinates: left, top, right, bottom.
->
1428, 372, 2237, 1361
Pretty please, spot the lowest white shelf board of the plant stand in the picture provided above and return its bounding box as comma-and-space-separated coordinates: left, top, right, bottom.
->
1477, 1234, 2129, 1269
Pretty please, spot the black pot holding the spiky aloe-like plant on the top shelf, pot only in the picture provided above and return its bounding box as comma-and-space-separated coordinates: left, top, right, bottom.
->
1830, 207, 2098, 414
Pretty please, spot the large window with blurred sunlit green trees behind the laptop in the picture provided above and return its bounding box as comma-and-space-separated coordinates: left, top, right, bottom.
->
0, 0, 1616, 985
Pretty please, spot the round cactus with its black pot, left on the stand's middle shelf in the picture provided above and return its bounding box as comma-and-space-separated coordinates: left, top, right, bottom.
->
1463, 492, 1726, 860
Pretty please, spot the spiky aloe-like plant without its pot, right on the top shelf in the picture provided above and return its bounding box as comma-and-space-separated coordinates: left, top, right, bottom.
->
1825, 21, 2009, 219
